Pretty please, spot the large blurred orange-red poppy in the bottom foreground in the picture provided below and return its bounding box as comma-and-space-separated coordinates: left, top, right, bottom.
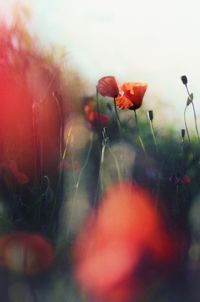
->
74, 183, 183, 302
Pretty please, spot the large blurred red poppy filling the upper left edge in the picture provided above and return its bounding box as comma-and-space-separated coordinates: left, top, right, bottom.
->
0, 24, 67, 183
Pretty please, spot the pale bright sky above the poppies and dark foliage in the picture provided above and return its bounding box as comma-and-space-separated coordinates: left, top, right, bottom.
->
0, 0, 200, 127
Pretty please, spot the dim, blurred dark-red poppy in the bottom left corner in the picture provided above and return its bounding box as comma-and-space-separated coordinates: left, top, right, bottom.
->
0, 232, 54, 275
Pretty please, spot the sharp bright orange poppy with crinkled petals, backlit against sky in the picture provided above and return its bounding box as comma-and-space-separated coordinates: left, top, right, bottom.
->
115, 83, 147, 110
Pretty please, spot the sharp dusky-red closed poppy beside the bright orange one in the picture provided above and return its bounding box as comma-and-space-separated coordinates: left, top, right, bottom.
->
97, 76, 119, 98
